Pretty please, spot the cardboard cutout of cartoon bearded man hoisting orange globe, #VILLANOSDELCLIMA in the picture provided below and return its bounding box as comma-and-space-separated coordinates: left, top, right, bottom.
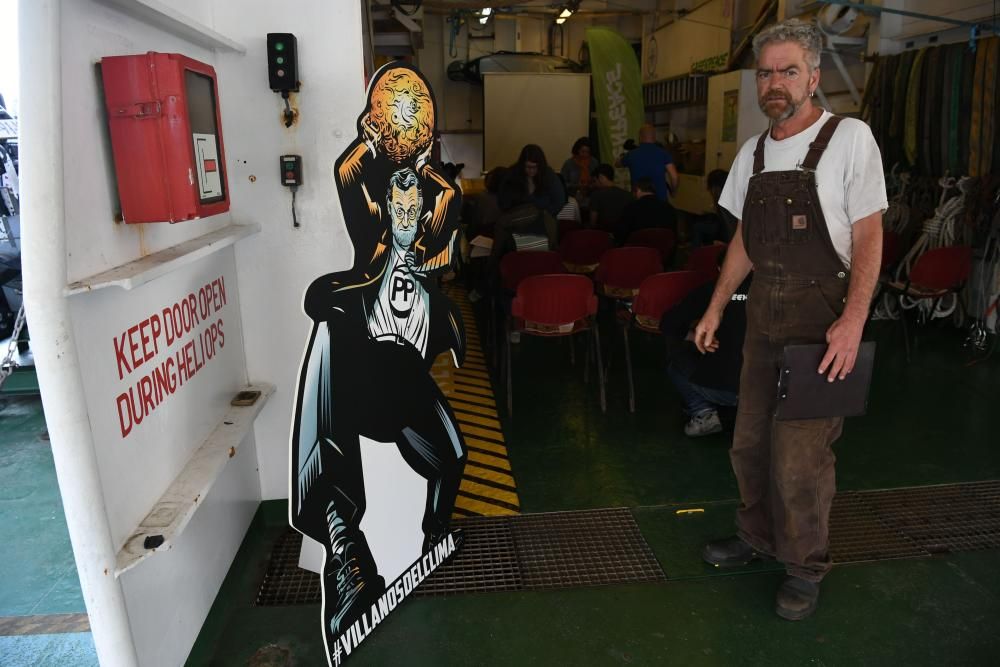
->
289, 63, 466, 664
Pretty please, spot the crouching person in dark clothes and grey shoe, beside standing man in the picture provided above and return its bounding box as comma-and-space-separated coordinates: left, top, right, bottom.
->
660, 253, 753, 437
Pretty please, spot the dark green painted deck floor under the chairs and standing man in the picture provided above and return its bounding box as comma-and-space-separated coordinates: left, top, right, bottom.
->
189, 323, 1000, 665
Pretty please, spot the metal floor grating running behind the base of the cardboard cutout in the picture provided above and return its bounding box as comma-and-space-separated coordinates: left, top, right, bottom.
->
254, 508, 665, 606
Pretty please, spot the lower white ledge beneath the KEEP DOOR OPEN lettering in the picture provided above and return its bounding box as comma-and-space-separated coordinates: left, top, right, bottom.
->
115, 383, 274, 577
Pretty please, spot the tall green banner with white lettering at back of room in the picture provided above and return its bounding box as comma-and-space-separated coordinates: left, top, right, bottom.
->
587, 28, 643, 163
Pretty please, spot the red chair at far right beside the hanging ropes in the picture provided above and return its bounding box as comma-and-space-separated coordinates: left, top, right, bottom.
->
885, 246, 972, 361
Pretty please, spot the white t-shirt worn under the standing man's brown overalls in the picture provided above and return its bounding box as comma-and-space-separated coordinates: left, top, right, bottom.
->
719, 111, 889, 268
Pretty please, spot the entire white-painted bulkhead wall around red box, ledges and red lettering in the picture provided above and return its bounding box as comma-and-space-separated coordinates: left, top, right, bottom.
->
45, 0, 365, 666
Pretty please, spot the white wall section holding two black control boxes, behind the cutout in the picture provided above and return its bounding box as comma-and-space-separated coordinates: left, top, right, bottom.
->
212, 0, 366, 500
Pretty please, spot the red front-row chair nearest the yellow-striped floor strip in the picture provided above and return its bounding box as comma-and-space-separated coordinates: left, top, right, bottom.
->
506, 274, 607, 415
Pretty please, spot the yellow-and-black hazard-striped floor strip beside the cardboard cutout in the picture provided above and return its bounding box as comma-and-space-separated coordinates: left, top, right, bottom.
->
431, 285, 521, 517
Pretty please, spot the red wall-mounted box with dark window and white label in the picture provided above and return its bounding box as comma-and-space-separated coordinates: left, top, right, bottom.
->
101, 51, 229, 223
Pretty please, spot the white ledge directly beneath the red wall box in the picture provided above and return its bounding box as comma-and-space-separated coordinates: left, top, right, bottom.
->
66, 223, 260, 296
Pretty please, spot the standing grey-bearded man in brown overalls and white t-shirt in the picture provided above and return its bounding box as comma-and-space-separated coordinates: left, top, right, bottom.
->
695, 19, 887, 620
